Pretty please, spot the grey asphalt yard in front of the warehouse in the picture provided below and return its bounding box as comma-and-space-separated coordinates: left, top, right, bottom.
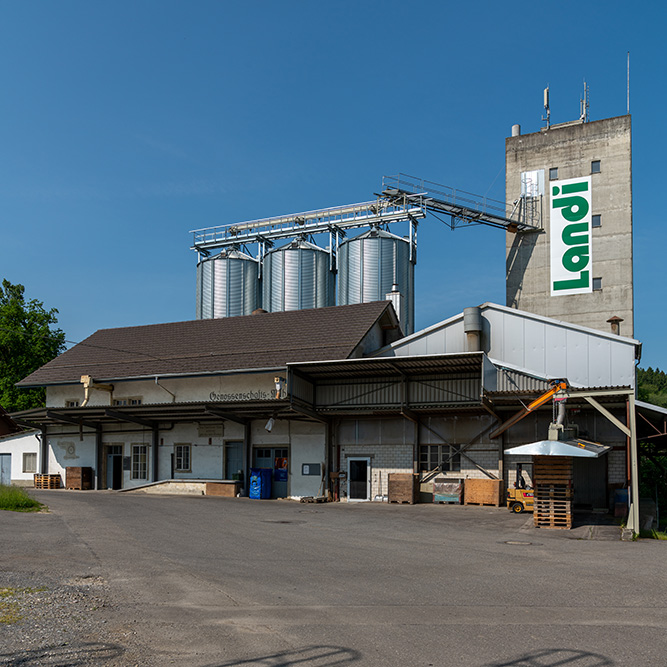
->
0, 491, 667, 667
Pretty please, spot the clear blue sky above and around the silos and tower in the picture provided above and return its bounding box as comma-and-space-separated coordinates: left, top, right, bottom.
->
0, 0, 667, 369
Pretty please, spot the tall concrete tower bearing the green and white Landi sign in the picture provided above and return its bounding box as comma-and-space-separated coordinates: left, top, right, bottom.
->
505, 115, 634, 337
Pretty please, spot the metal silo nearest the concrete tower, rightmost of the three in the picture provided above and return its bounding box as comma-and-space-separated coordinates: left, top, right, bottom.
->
338, 228, 415, 334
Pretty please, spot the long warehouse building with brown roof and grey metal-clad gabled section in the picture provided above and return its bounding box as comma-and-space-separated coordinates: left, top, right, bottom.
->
10, 301, 640, 524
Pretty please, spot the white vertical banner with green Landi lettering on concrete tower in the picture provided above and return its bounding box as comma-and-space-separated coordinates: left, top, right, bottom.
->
549, 176, 593, 296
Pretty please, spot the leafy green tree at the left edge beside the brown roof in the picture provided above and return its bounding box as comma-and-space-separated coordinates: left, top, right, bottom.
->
0, 280, 65, 412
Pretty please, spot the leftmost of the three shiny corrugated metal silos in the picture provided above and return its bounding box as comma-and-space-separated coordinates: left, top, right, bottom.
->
197, 249, 259, 319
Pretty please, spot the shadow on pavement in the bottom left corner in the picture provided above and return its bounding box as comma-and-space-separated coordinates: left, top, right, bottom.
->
0, 642, 125, 667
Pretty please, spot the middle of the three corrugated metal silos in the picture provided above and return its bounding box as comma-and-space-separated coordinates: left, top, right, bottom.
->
262, 239, 336, 313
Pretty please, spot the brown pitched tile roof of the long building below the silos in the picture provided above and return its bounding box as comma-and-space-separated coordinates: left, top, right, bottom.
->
17, 301, 395, 387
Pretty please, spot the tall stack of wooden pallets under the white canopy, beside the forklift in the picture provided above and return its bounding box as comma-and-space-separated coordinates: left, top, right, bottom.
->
533, 456, 573, 529
